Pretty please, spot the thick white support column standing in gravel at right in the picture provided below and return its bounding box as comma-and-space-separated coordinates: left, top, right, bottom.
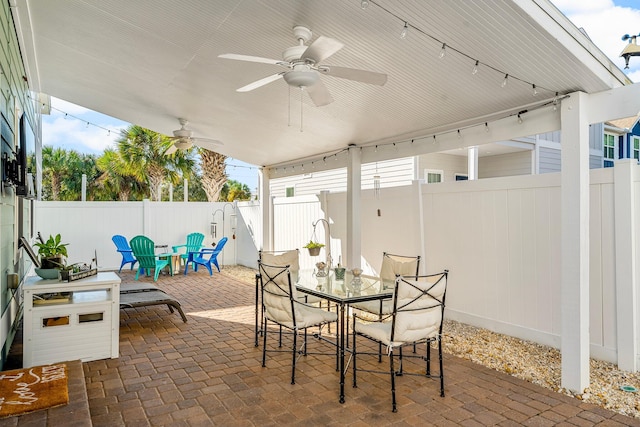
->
560, 92, 589, 393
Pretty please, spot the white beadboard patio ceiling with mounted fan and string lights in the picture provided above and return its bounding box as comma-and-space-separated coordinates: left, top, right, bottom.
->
11, 0, 630, 166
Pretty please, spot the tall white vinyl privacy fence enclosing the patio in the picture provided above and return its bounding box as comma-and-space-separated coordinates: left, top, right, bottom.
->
35, 163, 640, 370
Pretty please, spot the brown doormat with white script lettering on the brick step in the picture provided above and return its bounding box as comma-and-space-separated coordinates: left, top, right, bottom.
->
0, 363, 69, 418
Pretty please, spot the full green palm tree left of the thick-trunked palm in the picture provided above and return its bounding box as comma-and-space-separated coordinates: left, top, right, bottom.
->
116, 125, 195, 201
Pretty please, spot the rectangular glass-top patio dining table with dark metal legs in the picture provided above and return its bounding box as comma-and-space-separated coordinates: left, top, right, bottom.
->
291, 270, 395, 403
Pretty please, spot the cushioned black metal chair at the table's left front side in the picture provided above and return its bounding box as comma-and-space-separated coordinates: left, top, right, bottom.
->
258, 262, 338, 384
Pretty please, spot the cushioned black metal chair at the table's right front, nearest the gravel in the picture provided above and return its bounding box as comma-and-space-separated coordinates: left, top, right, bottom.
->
352, 270, 449, 412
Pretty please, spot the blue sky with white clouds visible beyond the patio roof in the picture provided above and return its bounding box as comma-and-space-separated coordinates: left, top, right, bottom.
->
42, 0, 640, 193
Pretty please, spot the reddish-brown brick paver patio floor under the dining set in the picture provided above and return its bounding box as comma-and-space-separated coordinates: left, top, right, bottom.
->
84, 272, 640, 427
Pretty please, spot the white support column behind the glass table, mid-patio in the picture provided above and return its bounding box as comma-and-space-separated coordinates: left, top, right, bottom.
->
345, 147, 362, 268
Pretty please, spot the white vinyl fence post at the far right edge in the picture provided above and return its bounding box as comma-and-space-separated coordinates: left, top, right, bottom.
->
613, 159, 638, 372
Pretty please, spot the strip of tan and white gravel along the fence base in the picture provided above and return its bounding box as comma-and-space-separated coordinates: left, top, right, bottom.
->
222, 266, 640, 418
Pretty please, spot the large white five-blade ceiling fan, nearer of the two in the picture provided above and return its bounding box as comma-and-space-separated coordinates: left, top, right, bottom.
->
218, 26, 387, 107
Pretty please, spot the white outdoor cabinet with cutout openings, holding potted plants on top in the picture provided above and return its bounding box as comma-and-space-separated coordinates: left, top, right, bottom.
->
22, 272, 120, 368
